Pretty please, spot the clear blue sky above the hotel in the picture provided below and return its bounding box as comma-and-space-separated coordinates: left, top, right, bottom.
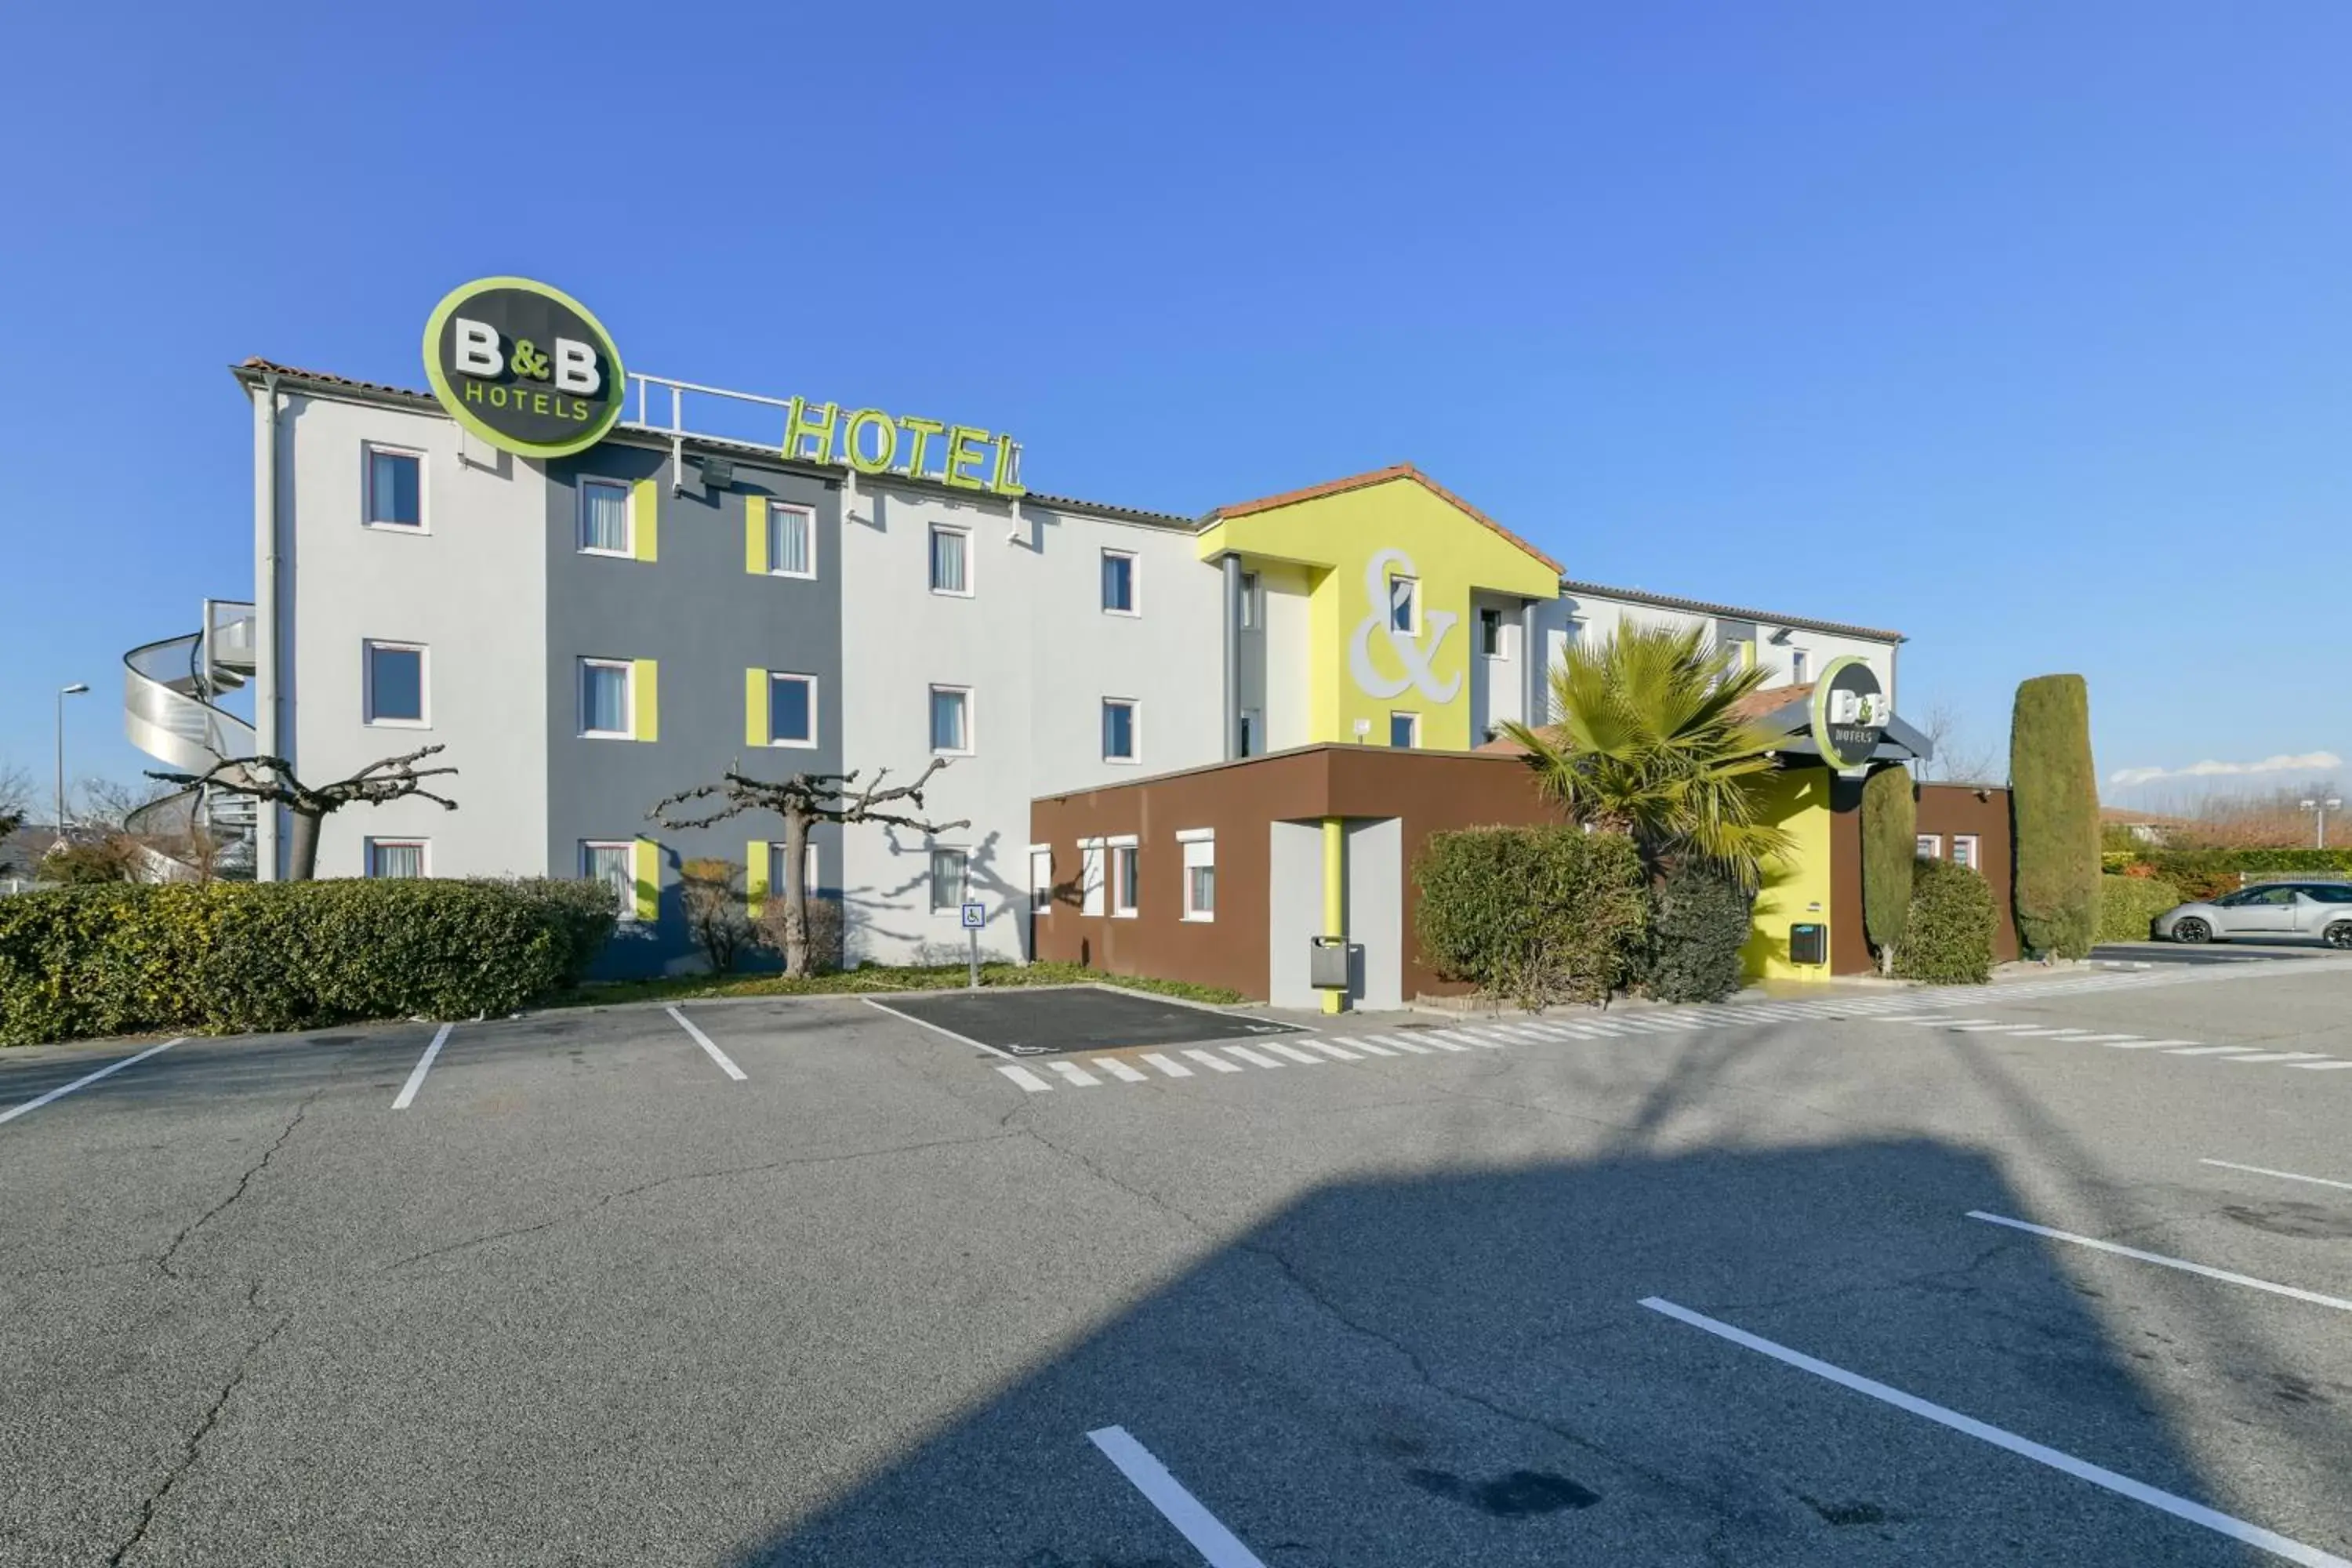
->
0, 0, 2352, 808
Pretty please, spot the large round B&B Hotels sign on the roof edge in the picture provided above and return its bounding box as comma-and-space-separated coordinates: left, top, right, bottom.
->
426, 278, 628, 459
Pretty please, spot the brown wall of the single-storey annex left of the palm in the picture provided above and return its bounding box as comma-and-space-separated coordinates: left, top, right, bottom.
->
1030, 746, 1559, 996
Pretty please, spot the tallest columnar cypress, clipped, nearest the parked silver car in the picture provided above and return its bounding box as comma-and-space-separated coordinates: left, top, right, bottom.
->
2009, 675, 2098, 959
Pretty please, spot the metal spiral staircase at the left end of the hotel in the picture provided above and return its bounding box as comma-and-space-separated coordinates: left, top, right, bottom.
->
122, 600, 256, 881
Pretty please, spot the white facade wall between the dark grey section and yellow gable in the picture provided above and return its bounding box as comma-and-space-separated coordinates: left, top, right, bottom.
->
840, 485, 1223, 964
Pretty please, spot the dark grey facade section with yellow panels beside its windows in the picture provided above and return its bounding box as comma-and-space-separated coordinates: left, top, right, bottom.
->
546, 442, 842, 978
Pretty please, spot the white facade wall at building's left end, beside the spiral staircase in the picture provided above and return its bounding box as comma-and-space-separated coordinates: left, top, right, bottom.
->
278, 395, 548, 877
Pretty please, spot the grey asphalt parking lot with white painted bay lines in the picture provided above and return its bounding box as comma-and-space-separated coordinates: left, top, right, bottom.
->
0, 959, 2352, 1568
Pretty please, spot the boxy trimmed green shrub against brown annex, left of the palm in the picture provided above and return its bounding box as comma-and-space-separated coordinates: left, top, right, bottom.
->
1414, 825, 1649, 1006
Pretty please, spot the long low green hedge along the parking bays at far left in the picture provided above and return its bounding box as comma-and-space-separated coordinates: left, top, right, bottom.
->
0, 881, 614, 1046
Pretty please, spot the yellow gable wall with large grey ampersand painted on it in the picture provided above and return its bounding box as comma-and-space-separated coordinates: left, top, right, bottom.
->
1200, 477, 1559, 750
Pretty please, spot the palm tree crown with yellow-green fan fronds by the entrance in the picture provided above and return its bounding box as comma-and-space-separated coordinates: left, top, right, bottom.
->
1503, 626, 1795, 888
